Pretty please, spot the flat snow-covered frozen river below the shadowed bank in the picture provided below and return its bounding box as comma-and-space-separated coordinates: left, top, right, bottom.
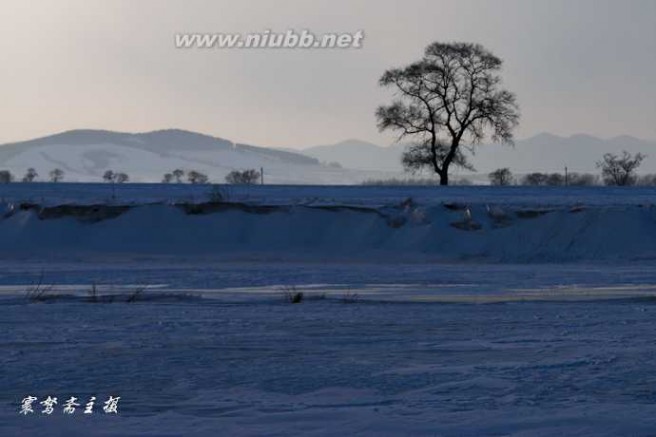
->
0, 261, 656, 436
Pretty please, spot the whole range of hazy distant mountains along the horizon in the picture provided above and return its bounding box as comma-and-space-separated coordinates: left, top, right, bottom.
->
0, 129, 656, 184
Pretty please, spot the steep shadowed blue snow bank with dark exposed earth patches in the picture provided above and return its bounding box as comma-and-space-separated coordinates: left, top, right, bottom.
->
0, 196, 656, 262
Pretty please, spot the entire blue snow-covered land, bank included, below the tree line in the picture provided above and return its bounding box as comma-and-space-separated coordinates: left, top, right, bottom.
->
0, 184, 656, 436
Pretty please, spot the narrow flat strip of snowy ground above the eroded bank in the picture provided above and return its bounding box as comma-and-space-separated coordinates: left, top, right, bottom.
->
0, 183, 656, 206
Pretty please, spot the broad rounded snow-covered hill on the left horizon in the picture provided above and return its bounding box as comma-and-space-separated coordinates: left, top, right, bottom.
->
0, 130, 400, 184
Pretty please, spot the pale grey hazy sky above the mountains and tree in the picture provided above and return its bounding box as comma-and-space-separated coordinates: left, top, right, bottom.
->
0, 0, 656, 148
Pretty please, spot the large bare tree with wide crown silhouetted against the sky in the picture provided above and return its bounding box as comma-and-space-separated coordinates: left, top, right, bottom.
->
376, 42, 519, 185
